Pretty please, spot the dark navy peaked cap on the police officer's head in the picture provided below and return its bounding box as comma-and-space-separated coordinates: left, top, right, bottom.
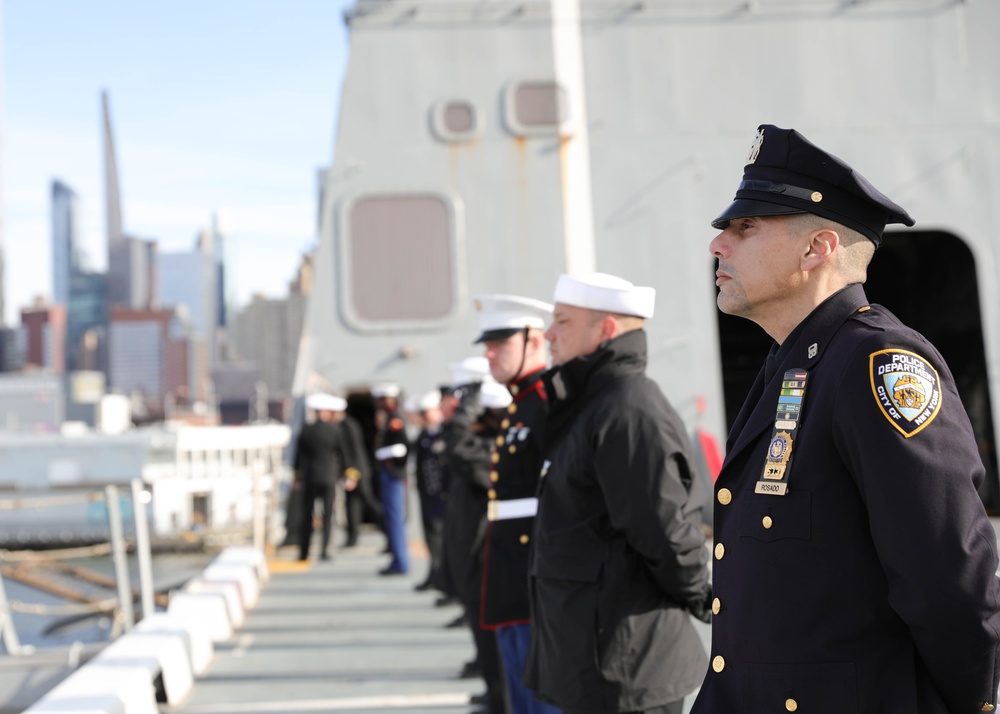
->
712, 124, 914, 248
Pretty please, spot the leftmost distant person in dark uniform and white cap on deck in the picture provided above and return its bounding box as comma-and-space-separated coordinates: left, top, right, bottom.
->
293, 394, 347, 560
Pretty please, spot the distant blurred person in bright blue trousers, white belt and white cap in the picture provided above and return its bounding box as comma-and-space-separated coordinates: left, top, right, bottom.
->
371, 383, 410, 575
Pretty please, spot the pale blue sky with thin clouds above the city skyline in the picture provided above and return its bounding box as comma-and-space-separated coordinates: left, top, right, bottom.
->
0, 0, 352, 324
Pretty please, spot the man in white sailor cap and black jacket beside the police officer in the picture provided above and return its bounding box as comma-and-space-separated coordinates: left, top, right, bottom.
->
525, 273, 712, 714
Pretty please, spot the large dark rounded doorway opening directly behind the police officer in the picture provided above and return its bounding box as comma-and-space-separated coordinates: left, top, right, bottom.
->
712, 231, 1000, 514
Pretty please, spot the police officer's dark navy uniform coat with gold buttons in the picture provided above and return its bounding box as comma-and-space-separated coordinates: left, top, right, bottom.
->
693, 285, 1000, 714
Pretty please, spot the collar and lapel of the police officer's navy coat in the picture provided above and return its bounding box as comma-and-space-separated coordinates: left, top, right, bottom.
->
723, 284, 868, 468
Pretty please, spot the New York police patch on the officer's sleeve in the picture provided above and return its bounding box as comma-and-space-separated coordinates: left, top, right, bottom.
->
868, 349, 941, 439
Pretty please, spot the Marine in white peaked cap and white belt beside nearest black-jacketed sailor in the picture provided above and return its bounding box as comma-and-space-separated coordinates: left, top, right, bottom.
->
473, 294, 559, 714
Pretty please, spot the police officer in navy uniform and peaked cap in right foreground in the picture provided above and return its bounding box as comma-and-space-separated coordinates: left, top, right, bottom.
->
693, 125, 1000, 714
